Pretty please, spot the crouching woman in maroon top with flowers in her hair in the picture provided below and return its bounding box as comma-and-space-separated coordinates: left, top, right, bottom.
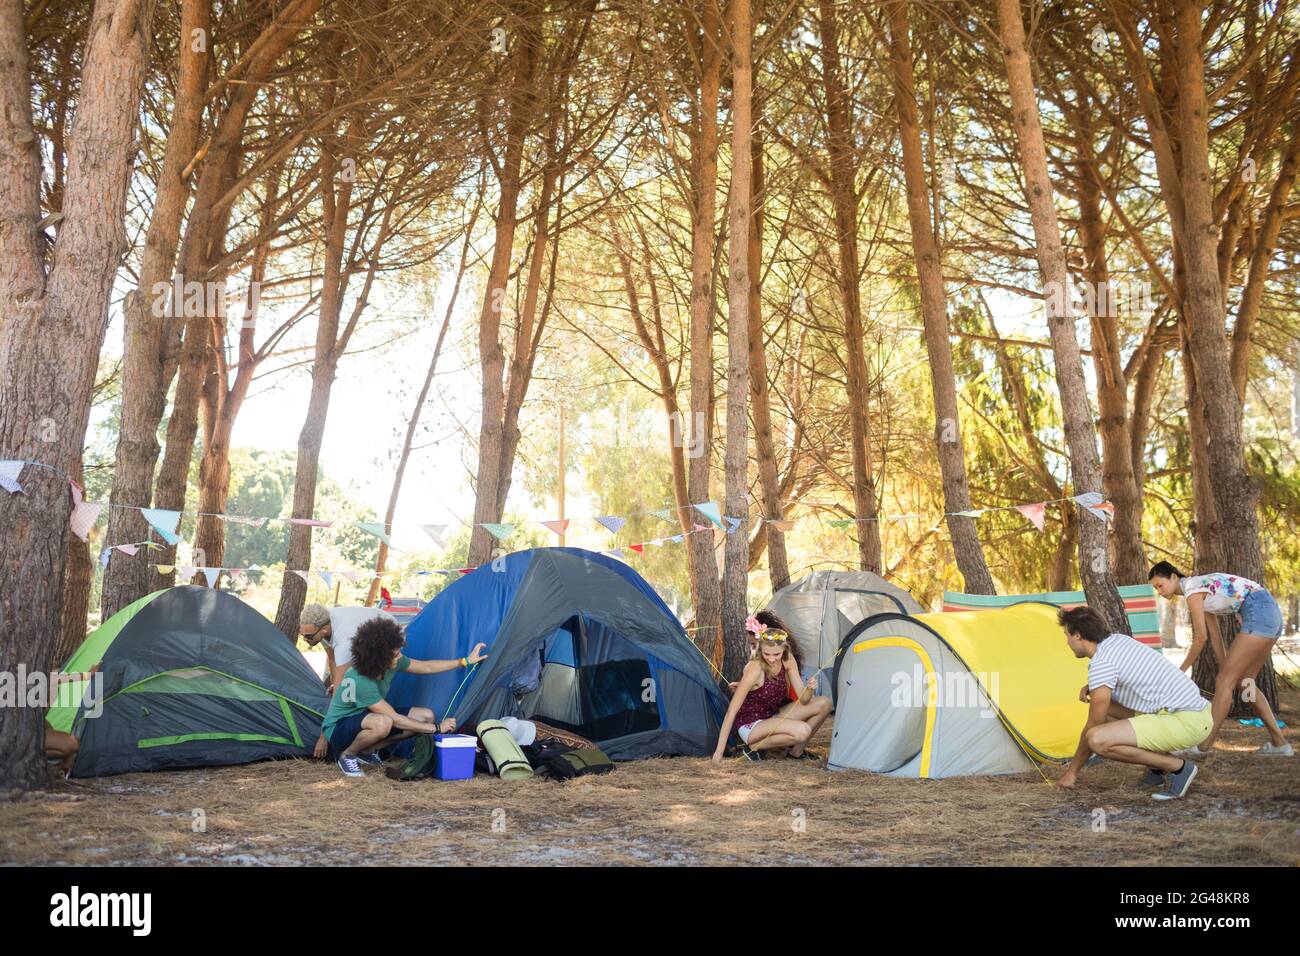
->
714, 617, 831, 763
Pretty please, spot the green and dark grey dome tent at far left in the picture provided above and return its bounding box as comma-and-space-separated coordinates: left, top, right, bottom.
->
60, 585, 329, 777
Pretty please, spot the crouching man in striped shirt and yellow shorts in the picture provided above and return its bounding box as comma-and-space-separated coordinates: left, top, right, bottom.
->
1057, 606, 1213, 800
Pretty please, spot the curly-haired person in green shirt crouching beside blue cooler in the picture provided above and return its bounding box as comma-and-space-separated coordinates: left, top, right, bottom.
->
321, 618, 488, 777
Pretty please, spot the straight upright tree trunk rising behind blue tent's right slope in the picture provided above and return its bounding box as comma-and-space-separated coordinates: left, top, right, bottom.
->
677, 0, 723, 658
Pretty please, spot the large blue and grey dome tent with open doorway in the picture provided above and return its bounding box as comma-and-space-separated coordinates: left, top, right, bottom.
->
389, 548, 727, 760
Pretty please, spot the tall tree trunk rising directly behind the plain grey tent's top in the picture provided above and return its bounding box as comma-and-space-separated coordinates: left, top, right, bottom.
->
820, 0, 884, 574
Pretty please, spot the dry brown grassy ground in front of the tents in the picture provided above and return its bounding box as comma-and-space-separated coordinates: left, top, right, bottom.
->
0, 689, 1300, 866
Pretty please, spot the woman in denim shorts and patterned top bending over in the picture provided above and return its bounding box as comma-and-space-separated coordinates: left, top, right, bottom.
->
1147, 561, 1295, 757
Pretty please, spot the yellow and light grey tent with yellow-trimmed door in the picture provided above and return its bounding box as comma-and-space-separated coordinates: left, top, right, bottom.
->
827, 604, 1088, 777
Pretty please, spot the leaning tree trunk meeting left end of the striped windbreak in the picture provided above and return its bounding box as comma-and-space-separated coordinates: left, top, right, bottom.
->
889, 3, 997, 594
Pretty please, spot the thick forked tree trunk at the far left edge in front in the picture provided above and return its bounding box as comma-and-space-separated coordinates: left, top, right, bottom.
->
0, 0, 155, 792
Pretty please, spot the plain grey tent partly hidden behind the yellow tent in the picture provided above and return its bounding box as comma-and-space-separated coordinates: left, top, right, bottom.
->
767, 571, 924, 697
